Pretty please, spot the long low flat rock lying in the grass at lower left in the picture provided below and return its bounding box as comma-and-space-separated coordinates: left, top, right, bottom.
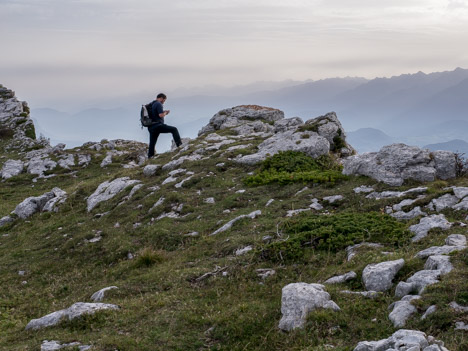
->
26, 302, 119, 330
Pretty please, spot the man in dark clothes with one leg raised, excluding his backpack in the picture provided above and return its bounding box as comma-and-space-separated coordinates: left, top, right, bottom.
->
148, 93, 182, 158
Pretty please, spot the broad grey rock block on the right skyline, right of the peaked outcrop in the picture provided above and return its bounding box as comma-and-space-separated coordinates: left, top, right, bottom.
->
343, 144, 456, 186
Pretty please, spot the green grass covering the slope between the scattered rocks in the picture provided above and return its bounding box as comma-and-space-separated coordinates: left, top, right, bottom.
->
0, 136, 468, 351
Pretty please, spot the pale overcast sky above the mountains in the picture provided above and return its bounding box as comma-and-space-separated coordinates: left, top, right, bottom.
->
0, 0, 468, 107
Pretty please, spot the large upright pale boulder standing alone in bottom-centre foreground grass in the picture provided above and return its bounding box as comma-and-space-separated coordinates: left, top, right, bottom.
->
278, 283, 340, 331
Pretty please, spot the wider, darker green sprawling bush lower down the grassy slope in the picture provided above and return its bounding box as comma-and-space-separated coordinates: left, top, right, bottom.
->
260, 212, 411, 261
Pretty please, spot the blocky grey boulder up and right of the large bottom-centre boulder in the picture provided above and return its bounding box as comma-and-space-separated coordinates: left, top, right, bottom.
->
362, 259, 405, 291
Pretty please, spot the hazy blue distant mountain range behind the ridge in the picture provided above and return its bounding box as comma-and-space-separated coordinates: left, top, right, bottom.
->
31, 68, 468, 151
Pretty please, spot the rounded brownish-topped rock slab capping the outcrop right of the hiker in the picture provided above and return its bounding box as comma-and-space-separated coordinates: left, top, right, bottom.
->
198, 105, 284, 136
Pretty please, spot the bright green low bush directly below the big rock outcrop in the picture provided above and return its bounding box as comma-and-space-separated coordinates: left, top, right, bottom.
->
244, 151, 348, 186
